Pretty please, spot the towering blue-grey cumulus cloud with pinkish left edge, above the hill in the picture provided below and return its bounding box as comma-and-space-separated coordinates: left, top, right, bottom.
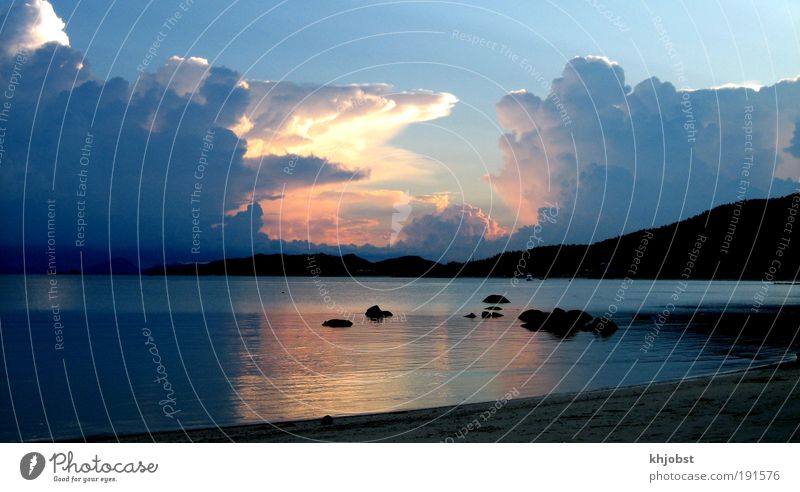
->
492, 57, 800, 242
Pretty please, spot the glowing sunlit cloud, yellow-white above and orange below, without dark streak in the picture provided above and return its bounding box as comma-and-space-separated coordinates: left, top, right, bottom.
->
219, 81, 457, 245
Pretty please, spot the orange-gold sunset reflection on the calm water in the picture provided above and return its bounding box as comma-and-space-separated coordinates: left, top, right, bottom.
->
228, 313, 543, 421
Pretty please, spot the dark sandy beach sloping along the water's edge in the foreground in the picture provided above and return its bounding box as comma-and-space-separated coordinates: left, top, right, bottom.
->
89, 362, 800, 443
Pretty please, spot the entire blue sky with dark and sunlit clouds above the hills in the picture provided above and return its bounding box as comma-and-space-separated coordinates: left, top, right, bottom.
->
0, 0, 800, 270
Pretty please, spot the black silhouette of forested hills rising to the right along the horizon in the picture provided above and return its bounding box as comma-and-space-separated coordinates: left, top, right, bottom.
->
152, 192, 800, 281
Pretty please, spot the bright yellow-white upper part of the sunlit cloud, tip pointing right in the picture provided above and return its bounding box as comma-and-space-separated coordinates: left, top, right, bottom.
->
238, 81, 458, 181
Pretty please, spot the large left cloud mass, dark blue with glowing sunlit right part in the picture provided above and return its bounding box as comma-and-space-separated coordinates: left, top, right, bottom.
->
0, 1, 456, 271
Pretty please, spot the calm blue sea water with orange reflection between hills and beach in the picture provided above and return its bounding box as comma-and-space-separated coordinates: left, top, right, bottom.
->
0, 276, 800, 441
